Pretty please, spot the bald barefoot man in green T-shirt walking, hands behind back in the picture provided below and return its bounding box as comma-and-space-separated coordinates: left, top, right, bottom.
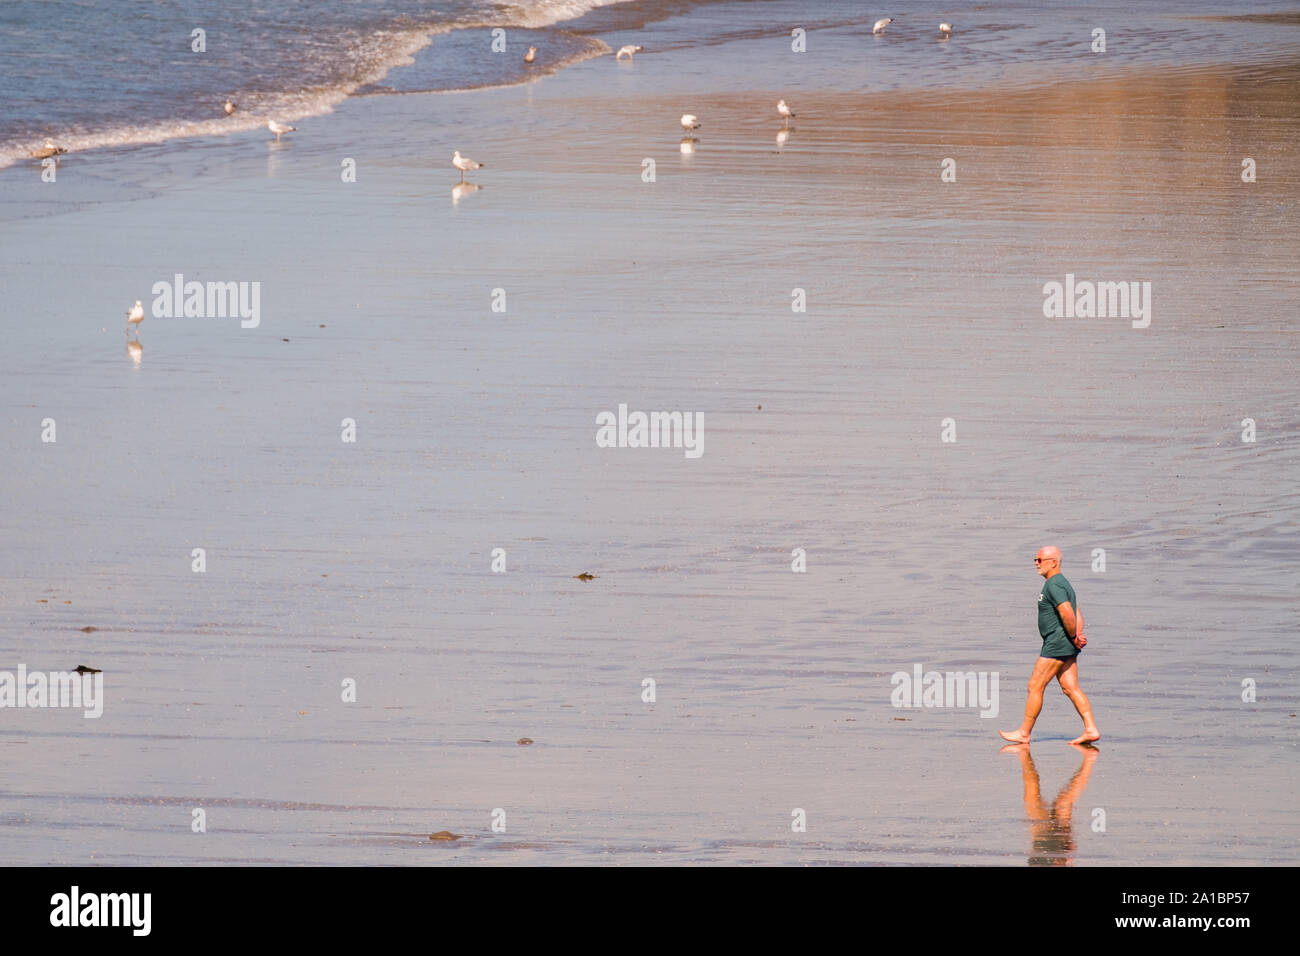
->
998, 546, 1101, 744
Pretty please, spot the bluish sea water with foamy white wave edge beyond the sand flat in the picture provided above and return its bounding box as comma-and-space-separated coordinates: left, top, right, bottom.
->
0, 0, 1300, 169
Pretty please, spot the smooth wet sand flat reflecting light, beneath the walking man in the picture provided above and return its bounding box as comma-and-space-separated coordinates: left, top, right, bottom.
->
0, 29, 1300, 865
